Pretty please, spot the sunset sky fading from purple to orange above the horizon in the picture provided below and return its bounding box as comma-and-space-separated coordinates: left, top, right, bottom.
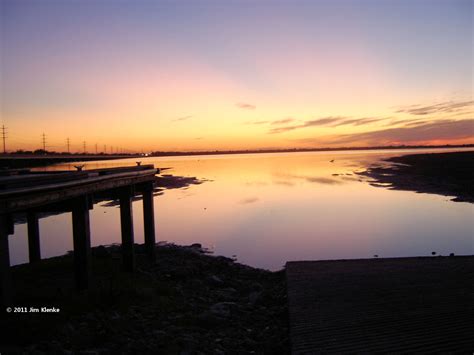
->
0, 0, 474, 151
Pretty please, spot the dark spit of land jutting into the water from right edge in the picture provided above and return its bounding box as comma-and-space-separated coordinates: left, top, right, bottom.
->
361, 152, 474, 203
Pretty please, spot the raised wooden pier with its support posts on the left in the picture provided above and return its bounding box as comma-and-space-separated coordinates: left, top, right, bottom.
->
0, 163, 158, 305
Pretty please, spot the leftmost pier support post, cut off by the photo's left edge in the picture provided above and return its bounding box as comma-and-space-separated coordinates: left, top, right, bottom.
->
0, 215, 12, 311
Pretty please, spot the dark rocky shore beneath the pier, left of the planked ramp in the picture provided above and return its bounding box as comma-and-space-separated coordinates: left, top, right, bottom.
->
0, 244, 289, 354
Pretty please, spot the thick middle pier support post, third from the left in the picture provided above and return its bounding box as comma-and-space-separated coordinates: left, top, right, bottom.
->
72, 196, 91, 291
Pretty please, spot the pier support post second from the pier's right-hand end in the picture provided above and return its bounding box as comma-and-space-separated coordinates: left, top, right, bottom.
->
119, 186, 135, 271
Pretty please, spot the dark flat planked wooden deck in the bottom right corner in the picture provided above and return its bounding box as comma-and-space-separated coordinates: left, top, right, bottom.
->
286, 256, 474, 354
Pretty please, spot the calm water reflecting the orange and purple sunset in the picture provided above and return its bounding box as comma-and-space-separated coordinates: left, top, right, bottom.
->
10, 150, 474, 270
